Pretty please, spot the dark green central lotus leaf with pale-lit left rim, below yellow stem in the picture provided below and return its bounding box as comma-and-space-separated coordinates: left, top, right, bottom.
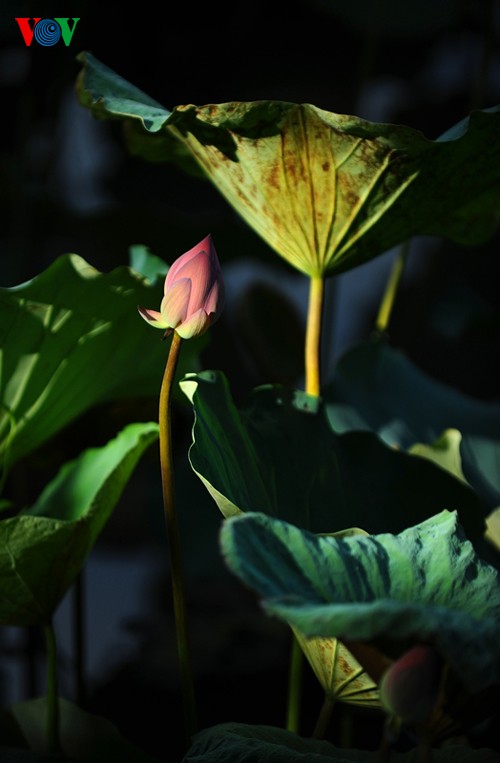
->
180, 372, 485, 538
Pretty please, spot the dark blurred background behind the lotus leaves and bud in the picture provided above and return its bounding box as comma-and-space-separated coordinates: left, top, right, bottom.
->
0, 0, 500, 755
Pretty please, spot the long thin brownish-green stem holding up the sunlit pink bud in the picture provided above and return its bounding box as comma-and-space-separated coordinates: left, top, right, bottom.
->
159, 331, 197, 738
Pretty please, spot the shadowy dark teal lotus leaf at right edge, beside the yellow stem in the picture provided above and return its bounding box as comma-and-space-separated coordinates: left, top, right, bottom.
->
324, 339, 500, 509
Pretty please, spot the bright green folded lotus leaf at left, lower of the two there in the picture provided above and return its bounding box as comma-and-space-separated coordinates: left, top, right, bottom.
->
0, 423, 158, 626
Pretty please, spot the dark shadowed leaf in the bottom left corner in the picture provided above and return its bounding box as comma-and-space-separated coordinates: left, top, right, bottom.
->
10, 697, 159, 763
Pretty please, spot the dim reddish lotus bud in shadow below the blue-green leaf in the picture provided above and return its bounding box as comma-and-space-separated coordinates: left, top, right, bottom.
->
379, 645, 441, 724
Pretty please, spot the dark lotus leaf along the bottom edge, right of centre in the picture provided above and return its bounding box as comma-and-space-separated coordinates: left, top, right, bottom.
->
182, 723, 498, 763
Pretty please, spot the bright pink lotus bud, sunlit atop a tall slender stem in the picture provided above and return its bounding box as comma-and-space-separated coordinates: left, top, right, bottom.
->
137, 234, 224, 339
